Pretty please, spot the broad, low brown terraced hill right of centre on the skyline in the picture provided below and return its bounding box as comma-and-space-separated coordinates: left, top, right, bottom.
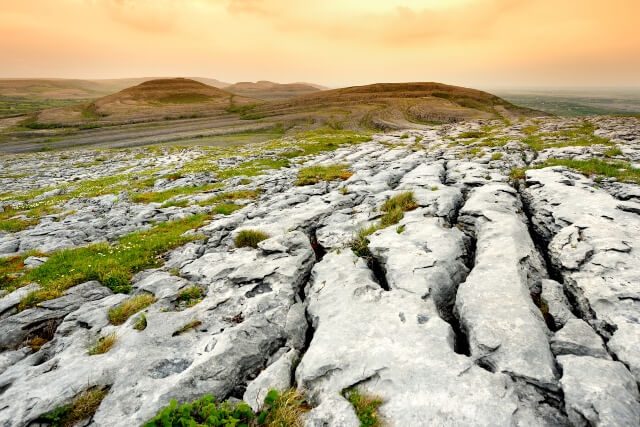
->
253, 83, 547, 130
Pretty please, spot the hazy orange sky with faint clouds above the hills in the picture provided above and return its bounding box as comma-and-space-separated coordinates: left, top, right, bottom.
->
0, 0, 640, 87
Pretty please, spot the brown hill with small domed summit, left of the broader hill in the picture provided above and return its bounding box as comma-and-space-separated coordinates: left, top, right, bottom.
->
36, 78, 256, 124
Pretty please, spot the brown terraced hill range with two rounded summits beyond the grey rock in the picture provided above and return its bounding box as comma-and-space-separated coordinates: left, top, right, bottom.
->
0, 78, 546, 152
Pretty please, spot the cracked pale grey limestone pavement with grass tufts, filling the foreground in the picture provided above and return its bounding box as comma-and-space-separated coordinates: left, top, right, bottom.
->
0, 117, 640, 426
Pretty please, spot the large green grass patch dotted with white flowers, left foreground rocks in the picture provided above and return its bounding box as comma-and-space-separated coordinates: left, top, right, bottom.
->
16, 215, 209, 311
